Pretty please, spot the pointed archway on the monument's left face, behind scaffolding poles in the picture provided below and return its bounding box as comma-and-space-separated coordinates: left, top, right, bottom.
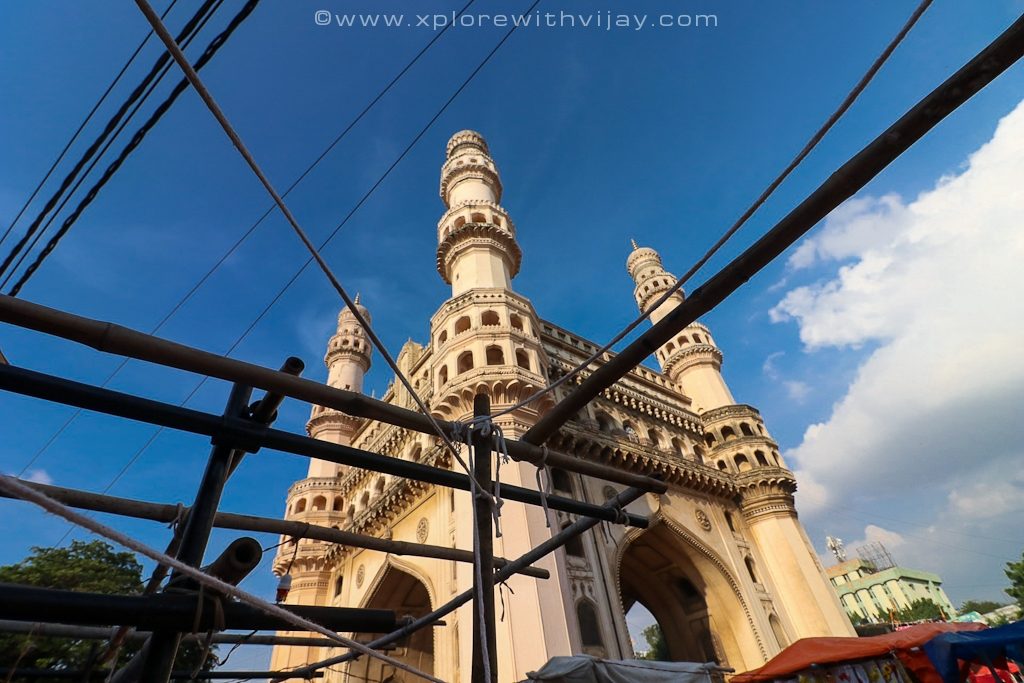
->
347, 566, 434, 683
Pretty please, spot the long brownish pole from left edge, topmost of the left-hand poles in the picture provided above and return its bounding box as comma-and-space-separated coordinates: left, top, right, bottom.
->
0, 296, 667, 494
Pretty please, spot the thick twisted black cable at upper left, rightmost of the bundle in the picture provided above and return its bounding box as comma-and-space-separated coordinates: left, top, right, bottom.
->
8, 0, 259, 296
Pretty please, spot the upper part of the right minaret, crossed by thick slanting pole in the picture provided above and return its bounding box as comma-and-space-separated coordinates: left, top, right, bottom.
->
626, 241, 735, 412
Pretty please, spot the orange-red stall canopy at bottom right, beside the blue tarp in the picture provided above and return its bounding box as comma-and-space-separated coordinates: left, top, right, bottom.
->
730, 623, 985, 683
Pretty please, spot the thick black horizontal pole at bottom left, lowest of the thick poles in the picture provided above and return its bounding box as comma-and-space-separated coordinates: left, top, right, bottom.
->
0, 583, 399, 633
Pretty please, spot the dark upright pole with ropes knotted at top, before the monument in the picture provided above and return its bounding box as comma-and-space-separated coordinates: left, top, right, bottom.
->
471, 393, 498, 683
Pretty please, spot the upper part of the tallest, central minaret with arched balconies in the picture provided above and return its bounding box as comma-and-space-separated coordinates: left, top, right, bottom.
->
431, 130, 547, 420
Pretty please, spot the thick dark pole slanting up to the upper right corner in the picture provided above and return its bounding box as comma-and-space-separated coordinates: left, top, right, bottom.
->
522, 16, 1024, 443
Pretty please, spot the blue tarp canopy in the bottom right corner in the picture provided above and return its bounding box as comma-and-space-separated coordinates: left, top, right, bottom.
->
924, 622, 1024, 683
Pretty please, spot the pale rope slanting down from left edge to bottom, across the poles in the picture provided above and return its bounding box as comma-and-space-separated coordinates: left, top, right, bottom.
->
0, 475, 443, 683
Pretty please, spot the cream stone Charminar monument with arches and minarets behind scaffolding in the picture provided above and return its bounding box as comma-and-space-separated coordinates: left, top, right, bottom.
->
271, 130, 854, 683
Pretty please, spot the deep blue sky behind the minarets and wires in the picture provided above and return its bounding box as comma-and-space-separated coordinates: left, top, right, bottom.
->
0, 0, 1024, 671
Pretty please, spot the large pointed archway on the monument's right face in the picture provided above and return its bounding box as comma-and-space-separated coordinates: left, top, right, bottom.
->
613, 512, 767, 670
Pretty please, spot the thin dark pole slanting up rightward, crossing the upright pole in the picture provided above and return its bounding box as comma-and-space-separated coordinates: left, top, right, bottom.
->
282, 488, 645, 683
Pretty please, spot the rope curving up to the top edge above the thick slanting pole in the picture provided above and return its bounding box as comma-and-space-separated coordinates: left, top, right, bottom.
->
471, 0, 933, 418
